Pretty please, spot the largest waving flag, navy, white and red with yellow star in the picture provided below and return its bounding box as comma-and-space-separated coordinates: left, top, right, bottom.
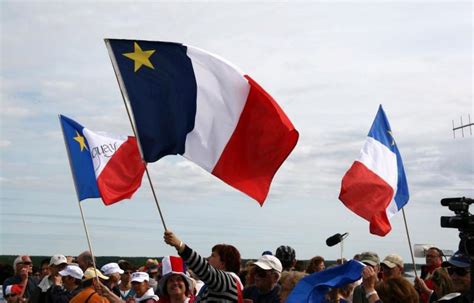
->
106, 39, 298, 205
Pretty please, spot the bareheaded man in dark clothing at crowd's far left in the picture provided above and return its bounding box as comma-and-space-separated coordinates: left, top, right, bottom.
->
3, 255, 36, 298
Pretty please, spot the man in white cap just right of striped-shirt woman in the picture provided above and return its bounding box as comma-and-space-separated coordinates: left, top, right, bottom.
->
243, 255, 283, 303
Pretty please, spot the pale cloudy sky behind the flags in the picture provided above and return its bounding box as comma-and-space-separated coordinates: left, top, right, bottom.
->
0, 1, 474, 263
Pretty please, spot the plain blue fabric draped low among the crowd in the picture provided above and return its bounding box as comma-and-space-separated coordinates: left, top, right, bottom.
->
286, 260, 364, 303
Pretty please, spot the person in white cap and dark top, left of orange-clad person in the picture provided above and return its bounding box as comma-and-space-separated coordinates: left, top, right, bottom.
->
49, 265, 84, 303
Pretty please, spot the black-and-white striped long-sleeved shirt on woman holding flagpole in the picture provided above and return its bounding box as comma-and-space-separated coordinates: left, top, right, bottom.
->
179, 245, 242, 303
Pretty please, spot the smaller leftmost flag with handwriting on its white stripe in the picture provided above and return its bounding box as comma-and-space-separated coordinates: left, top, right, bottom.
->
59, 115, 145, 205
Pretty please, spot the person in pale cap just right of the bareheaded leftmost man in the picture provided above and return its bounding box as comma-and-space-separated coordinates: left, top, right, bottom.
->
29, 255, 67, 303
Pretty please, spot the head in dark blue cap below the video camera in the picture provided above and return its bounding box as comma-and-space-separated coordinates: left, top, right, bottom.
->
448, 251, 471, 293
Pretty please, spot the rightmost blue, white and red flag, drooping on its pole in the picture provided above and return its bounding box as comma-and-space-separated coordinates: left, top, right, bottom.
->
339, 105, 409, 236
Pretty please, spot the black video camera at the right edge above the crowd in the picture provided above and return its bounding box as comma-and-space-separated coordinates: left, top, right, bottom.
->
441, 197, 474, 258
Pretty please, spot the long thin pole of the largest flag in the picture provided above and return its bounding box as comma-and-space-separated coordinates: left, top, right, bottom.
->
104, 39, 168, 231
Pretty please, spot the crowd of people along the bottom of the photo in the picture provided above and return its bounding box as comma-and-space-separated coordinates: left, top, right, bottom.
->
2, 230, 473, 303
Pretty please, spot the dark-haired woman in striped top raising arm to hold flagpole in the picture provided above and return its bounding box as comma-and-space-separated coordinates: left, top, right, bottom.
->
164, 230, 243, 302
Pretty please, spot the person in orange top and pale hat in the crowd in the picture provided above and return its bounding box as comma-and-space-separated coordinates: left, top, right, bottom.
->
70, 267, 109, 303
